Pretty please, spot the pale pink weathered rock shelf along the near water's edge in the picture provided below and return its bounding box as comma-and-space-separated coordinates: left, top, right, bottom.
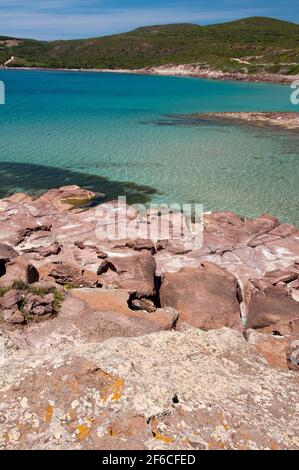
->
0, 187, 299, 289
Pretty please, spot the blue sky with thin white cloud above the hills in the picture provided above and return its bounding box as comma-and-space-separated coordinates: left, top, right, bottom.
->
0, 0, 299, 39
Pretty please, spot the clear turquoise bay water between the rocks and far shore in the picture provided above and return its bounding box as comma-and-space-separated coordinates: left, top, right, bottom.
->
0, 70, 299, 224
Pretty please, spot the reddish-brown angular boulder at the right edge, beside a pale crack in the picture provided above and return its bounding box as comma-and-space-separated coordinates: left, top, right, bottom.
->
245, 278, 299, 336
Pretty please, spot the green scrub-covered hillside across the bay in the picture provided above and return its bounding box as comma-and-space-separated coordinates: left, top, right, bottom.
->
0, 17, 299, 74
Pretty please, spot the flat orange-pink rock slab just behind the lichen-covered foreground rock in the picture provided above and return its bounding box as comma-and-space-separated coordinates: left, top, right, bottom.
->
2, 288, 178, 349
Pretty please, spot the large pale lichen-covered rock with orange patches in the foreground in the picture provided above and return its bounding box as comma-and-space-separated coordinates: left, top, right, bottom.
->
0, 329, 299, 450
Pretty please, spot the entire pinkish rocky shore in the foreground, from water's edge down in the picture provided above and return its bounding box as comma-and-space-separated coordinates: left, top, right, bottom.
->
0, 186, 299, 450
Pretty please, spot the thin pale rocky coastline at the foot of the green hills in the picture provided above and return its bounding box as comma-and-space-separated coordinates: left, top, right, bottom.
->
0, 64, 299, 85
